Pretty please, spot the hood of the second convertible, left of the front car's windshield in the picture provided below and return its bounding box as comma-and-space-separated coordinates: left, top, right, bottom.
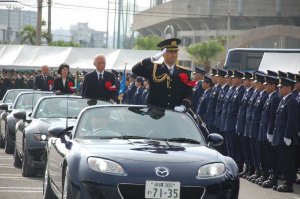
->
30, 118, 76, 133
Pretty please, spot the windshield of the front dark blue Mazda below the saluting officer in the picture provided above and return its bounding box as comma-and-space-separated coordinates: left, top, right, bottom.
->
75, 106, 204, 144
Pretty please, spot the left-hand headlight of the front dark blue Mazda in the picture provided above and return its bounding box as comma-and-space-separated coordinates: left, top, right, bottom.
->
88, 157, 125, 176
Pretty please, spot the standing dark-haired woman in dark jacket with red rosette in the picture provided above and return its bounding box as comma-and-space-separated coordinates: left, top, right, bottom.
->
53, 64, 75, 94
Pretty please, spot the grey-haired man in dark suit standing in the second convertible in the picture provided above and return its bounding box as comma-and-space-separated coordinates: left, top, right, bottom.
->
81, 55, 117, 102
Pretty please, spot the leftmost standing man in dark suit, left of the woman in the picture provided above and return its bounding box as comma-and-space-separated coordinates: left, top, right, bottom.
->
34, 65, 53, 91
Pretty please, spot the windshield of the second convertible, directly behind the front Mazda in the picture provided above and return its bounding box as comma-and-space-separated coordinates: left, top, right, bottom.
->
34, 97, 88, 118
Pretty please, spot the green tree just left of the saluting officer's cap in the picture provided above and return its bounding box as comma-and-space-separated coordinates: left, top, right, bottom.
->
134, 35, 163, 50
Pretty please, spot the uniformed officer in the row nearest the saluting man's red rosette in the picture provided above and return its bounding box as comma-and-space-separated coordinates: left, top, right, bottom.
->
192, 67, 206, 112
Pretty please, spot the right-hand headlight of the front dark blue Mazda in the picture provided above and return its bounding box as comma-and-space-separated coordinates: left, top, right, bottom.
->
197, 163, 226, 178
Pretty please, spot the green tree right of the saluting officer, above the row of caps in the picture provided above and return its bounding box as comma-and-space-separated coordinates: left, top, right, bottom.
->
187, 40, 224, 71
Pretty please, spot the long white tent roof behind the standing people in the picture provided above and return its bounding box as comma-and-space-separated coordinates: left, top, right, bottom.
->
0, 45, 190, 70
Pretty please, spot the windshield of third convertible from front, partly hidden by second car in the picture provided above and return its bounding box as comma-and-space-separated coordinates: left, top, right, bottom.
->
13, 93, 54, 109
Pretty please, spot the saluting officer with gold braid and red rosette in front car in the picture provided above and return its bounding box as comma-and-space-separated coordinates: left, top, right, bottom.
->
132, 38, 195, 112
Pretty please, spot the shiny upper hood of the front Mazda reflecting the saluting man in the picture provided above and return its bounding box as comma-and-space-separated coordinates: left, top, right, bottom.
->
77, 139, 220, 164
